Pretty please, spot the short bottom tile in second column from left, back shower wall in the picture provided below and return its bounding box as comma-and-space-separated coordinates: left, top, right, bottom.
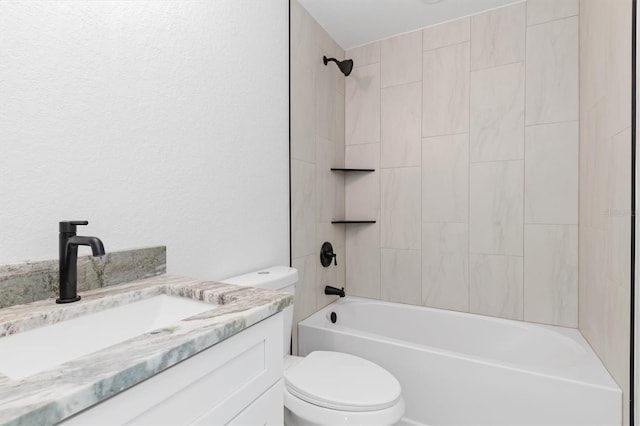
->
380, 249, 422, 305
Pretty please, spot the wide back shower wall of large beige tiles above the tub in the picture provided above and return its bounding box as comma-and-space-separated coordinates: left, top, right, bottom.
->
345, 0, 579, 327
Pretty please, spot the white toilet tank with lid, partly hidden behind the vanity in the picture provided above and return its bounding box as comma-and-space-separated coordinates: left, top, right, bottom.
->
220, 266, 298, 355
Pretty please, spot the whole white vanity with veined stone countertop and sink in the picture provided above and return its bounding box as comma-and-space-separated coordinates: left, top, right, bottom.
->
0, 274, 293, 425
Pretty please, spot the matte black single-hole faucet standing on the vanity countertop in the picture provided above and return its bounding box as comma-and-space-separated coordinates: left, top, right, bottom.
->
56, 220, 104, 303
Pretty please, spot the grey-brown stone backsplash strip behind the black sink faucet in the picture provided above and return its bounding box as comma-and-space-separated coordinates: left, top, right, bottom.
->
0, 246, 167, 308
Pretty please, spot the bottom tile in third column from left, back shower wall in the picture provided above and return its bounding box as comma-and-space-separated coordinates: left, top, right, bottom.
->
422, 223, 469, 311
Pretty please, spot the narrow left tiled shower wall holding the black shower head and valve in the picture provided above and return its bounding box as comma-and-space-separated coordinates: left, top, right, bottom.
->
290, 0, 345, 352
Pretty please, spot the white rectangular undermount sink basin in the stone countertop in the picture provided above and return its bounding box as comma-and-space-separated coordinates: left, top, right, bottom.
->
0, 294, 216, 379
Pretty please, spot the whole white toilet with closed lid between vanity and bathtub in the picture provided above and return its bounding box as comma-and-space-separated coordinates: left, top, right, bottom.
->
222, 266, 405, 426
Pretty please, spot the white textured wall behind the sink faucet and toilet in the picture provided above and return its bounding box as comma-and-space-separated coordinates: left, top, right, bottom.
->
0, 0, 289, 279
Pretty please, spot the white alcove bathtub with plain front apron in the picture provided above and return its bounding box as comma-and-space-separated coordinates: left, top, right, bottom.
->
298, 297, 622, 426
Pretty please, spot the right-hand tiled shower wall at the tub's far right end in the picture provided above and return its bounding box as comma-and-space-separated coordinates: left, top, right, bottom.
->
579, 0, 632, 424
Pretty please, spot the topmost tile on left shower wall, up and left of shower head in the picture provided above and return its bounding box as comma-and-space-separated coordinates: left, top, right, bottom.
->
289, 0, 318, 69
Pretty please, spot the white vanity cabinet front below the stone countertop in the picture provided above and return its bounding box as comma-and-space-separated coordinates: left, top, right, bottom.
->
61, 313, 284, 425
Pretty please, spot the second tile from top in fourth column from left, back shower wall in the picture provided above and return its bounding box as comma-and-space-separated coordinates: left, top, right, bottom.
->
469, 63, 525, 162
